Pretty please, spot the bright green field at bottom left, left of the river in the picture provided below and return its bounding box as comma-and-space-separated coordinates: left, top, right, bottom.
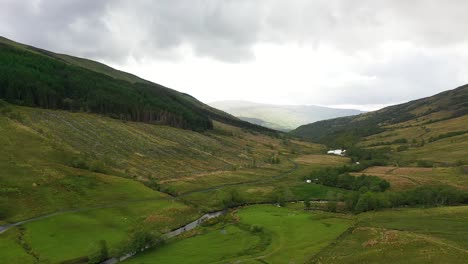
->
0, 200, 198, 263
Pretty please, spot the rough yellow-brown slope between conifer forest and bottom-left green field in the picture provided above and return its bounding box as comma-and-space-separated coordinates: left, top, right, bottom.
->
0, 102, 303, 220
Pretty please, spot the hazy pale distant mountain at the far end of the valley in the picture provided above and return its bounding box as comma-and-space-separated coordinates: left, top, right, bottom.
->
209, 101, 363, 130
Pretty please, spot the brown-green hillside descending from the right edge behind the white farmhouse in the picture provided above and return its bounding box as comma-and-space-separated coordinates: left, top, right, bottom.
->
292, 85, 468, 165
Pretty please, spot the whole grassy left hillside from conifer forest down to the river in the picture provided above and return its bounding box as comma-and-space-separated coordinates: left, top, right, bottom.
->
0, 103, 328, 263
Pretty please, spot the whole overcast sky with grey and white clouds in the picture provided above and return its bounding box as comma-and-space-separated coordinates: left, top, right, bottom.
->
0, 0, 468, 110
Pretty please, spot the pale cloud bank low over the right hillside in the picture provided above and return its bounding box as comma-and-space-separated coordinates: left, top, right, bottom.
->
303, 52, 468, 105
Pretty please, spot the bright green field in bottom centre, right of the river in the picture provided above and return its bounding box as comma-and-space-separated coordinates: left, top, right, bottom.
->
126, 205, 352, 264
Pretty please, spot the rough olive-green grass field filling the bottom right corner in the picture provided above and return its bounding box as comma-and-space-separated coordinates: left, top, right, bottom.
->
310, 206, 468, 263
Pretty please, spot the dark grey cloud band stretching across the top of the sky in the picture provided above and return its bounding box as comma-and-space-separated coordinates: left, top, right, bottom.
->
0, 0, 468, 62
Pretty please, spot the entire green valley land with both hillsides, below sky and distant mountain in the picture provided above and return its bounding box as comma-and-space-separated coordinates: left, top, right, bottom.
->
0, 35, 468, 264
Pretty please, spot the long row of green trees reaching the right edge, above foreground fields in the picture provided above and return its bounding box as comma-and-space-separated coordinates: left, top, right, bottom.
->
344, 185, 468, 213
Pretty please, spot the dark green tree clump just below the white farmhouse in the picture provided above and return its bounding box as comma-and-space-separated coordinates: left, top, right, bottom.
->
308, 166, 390, 192
